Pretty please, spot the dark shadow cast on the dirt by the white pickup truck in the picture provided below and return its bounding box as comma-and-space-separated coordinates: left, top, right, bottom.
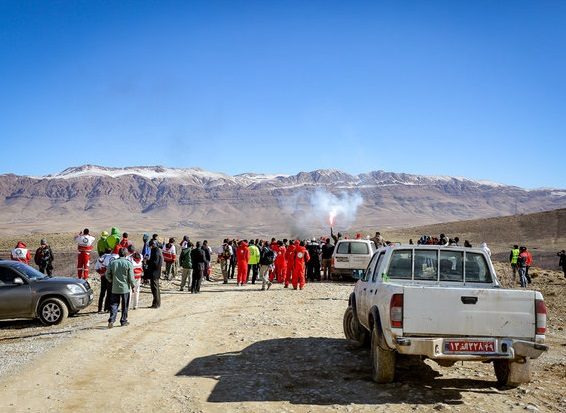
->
177, 337, 502, 405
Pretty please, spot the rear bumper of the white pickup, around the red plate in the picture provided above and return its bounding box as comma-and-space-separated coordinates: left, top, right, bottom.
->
395, 337, 548, 361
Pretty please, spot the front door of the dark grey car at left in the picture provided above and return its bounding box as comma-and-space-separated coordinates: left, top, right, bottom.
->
0, 266, 33, 318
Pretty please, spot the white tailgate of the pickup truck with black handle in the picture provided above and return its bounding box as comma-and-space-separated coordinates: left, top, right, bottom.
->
403, 286, 536, 338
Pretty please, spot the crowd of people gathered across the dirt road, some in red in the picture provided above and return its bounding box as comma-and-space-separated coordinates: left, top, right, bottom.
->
11, 227, 566, 328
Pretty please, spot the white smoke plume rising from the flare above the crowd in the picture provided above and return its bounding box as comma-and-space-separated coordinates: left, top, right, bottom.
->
284, 189, 363, 239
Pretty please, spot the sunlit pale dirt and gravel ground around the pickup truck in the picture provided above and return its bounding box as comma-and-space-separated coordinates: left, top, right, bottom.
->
0, 260, 566, 412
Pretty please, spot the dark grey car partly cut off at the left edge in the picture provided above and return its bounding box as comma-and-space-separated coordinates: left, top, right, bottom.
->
0, 260, 93, 325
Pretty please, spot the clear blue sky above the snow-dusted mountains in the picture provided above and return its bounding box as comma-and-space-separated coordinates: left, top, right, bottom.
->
0, 0, 566, 188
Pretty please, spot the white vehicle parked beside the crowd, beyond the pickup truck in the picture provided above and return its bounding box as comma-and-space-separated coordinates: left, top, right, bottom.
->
331, 239, 377, 279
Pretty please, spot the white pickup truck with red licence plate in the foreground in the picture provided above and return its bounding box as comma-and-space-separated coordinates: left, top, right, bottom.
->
344, 245, 548, 387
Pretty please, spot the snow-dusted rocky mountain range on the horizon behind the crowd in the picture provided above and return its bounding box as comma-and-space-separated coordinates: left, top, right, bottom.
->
0, 165, 566, 237
